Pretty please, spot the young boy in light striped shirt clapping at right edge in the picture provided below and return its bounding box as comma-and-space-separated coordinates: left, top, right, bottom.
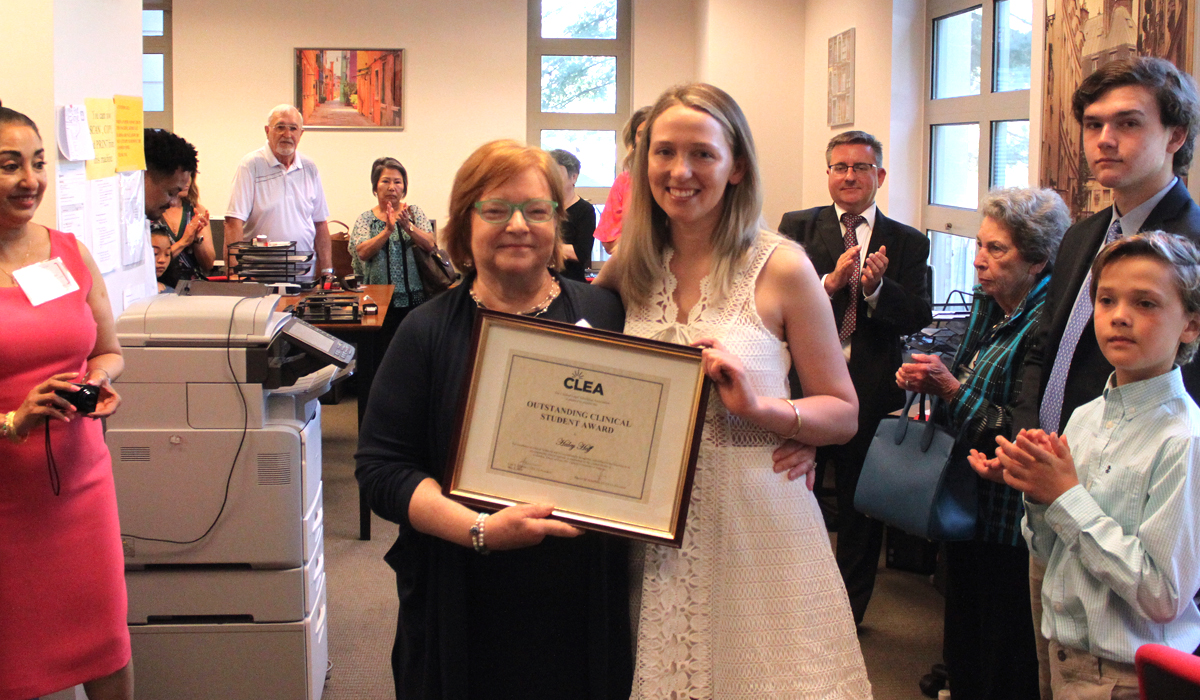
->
971, 232, 1200, 700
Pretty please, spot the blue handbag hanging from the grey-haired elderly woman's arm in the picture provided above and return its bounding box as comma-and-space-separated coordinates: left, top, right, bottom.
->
854, 393, 979, 540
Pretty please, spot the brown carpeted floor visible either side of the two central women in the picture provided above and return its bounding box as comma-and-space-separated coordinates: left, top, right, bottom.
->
323, 394, 942, 700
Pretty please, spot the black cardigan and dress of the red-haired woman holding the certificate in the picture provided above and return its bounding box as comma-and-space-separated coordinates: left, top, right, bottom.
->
355, 279, 632, 700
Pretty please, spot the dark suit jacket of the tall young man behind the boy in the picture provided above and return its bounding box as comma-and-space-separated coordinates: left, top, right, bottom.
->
1013, 181, 1200, 432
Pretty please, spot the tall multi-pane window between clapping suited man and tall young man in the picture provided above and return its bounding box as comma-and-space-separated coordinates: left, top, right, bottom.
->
923, 0, 1033, 303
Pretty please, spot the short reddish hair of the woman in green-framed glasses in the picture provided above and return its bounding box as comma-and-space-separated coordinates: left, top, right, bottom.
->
443, 139, 566, 270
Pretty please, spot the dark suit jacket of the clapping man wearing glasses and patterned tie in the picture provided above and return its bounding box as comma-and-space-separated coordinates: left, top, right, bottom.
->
779, 205, 932, 417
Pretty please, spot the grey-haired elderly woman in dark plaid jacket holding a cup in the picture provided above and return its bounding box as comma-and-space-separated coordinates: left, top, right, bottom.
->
896, 189, 1070, 700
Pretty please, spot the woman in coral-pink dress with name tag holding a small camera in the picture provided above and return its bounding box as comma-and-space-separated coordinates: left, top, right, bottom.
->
0, 107, 133, 700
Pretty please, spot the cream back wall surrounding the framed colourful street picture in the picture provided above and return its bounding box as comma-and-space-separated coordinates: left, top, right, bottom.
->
173, 0, 527, 226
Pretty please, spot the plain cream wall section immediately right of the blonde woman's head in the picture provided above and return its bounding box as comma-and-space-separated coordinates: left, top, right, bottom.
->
697, 0, 806, 227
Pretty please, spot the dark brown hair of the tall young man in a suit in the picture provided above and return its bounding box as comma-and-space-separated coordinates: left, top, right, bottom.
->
1070, 56, 1200, 175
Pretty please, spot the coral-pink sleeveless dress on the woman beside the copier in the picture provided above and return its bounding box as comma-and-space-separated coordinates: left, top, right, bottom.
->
0, 231, 130, 700
